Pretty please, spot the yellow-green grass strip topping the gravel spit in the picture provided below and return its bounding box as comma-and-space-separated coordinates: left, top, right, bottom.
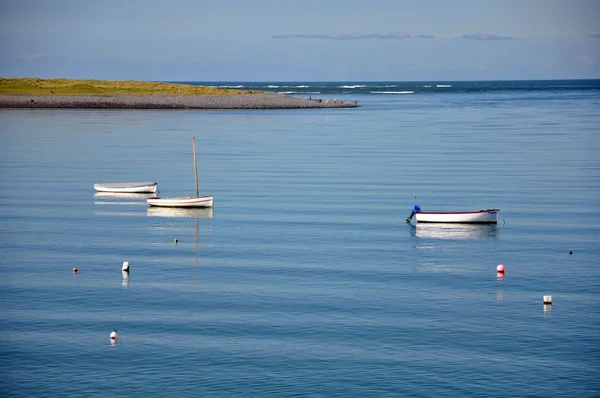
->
0, 78, 258, 95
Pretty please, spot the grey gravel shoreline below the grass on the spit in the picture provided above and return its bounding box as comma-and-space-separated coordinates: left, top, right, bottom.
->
0, 92, 359, 109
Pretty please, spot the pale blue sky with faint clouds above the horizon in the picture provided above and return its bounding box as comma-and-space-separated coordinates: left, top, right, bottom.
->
0, 0, 600, 82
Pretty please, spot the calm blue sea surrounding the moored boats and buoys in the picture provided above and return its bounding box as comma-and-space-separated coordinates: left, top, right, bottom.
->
0, 80, 600, 397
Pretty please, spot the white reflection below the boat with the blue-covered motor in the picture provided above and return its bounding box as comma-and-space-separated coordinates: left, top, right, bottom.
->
411, 223, 498, 239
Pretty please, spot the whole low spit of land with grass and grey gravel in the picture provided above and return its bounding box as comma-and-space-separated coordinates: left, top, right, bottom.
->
0, 78, 358, 109
